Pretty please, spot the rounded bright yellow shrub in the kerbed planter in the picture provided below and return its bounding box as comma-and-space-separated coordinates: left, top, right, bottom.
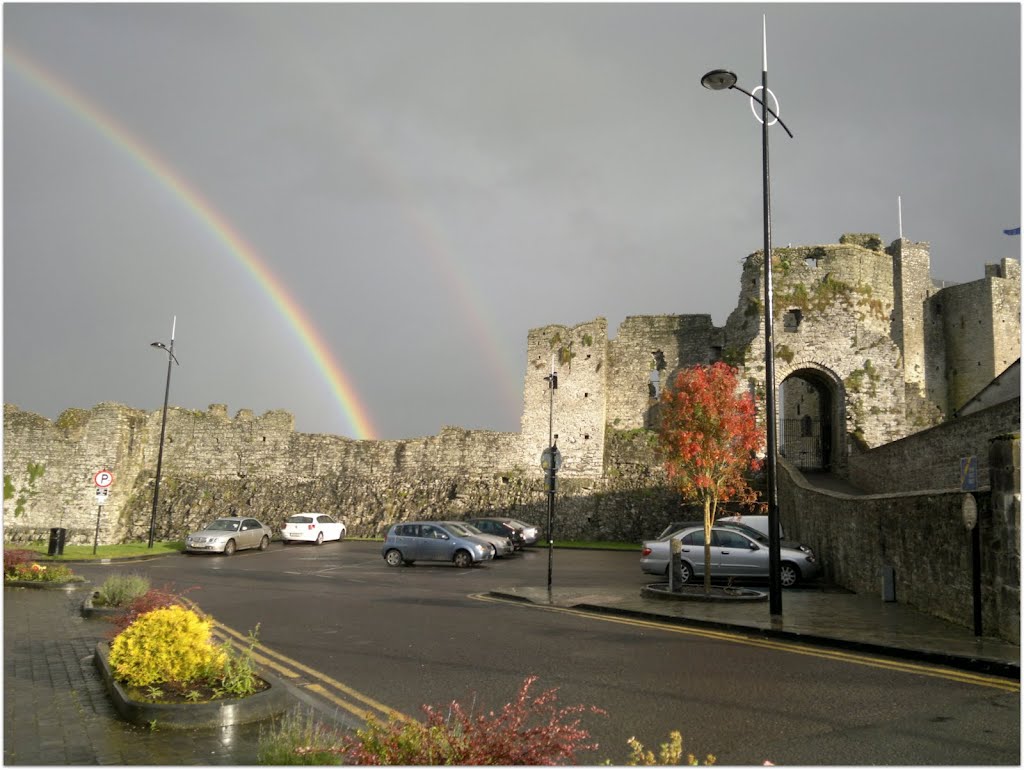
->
110, 606, 223, 687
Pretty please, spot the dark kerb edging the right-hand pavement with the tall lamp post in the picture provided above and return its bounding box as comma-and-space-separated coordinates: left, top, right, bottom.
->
486, 591, 1021, 682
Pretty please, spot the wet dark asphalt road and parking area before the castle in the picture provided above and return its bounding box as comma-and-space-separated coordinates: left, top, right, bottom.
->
76, 542, 1020, 766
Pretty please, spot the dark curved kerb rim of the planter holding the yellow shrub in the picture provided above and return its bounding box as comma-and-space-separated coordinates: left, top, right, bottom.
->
94, 642, 292, 728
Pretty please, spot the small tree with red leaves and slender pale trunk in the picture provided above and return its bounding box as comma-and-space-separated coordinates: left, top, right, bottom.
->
658, 361, 764, 592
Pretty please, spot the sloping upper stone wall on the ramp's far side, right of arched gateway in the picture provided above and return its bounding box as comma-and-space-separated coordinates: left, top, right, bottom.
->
850, 396, 1021, 493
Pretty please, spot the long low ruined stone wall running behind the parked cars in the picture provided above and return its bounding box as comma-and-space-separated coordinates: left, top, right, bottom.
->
4, 403, 680, 544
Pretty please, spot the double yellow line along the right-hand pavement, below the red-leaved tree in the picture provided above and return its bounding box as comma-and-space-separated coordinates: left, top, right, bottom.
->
471, 594, 1021, 692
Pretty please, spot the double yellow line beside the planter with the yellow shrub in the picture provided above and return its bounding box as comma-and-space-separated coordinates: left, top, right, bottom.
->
184, 599, 412, 722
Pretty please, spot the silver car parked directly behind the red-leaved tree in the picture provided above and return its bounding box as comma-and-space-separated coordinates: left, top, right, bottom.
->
640, 526, 821, 588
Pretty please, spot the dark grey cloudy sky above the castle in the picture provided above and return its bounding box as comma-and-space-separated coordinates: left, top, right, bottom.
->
3, 3, 1021, 438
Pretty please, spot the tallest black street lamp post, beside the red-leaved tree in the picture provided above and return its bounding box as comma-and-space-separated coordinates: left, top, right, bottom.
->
700, 24, 793, 615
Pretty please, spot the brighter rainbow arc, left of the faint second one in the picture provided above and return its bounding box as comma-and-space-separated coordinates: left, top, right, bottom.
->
4, 46, 377, 439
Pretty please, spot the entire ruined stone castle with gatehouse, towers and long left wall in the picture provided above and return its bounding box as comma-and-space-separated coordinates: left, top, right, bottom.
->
4, 234, 1021, 638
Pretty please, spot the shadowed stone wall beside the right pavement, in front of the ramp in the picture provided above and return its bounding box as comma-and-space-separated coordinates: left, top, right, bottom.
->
778, 442, 1020, 644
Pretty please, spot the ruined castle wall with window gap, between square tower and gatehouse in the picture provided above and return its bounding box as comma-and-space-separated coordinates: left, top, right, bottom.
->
607, 315, 725, 430
